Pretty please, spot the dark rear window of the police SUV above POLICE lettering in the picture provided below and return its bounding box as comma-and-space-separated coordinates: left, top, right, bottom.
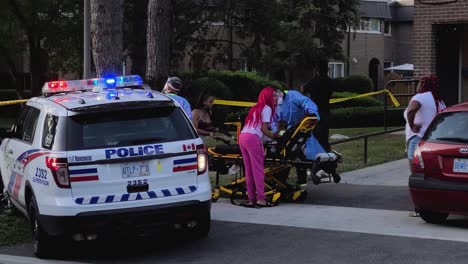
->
67, 106, 196, 150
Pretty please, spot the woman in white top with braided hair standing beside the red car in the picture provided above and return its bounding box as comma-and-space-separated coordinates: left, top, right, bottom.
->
404, 75, 445, 168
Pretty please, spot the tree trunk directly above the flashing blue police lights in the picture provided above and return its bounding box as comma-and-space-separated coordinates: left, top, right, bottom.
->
91, 0, 123, 77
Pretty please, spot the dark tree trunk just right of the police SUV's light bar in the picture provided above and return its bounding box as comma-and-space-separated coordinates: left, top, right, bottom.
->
146, 0, 172, 88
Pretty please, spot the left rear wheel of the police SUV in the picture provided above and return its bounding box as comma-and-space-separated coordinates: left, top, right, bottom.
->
28, 196, 52, 258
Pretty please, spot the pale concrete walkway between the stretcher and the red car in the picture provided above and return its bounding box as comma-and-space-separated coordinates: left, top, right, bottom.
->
341, 159, 410, 186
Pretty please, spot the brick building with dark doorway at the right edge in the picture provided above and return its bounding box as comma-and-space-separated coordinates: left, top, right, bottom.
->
413, 0, 468, 105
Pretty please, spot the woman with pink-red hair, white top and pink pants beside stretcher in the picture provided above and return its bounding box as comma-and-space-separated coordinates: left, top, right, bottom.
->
239, 87, 277, 207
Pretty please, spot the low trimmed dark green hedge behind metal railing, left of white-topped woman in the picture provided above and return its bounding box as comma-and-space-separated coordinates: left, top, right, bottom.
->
330, 106, 405, 128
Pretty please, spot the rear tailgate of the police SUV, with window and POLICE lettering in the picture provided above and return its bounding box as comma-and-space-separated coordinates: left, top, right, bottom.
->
67, 105, 197, 205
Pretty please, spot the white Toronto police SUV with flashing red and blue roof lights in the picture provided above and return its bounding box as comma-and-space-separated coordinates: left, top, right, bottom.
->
0, 75, 211, 257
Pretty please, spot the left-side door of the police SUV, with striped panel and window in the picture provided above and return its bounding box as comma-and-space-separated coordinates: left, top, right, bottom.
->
2, 105, 41, 207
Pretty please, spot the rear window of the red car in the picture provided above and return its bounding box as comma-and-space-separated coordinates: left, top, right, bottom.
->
425, 112, 468, 143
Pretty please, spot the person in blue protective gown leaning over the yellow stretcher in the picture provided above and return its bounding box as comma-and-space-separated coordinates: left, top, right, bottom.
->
272, 90, 325, 187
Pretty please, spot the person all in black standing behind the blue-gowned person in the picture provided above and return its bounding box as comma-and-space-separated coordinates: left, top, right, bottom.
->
303, 61, 334, 152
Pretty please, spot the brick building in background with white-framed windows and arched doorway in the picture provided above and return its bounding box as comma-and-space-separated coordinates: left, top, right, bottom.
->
329, 0, 414, 90
